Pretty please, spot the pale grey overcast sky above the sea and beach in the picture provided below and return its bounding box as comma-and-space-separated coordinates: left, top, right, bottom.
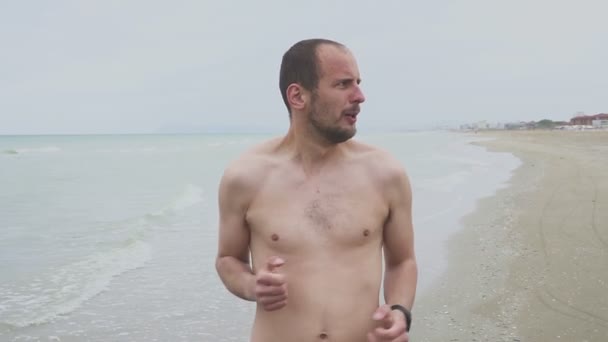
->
0, 0, 608, 134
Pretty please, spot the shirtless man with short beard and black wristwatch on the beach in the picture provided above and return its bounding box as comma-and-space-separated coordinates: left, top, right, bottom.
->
216, 39, 417, 342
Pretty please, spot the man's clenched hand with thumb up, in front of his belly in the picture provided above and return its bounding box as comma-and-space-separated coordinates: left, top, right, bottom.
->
255, 256, 287, 311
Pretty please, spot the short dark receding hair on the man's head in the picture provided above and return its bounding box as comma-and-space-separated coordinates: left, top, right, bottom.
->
279, 38, 345, 116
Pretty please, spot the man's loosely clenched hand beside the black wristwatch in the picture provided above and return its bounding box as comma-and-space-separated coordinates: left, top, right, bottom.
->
367, 305, 410, 342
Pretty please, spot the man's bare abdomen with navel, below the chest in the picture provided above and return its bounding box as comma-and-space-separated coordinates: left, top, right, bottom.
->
252, 250, 382, 342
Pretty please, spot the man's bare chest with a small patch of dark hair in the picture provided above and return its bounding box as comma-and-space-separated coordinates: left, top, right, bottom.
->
247, 172, 388, 253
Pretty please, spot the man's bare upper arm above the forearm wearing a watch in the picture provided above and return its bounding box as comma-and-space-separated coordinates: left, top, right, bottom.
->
384, 161, 415, 265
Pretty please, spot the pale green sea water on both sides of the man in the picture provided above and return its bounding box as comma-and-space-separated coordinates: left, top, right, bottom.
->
0, 132, 519, 341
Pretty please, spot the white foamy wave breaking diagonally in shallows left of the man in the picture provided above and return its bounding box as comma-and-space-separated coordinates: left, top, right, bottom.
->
0, 184, 204, 331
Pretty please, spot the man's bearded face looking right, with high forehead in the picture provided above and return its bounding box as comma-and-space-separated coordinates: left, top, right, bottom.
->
309, 45, 365, 144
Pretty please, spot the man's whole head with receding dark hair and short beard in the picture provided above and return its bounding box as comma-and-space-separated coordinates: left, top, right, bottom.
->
279, 39, 365, 143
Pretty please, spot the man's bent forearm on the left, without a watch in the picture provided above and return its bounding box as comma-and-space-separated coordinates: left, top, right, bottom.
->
215, 256, 255, 301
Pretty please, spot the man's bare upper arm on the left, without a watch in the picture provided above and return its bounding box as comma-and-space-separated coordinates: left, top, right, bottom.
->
218, 164, 252, 263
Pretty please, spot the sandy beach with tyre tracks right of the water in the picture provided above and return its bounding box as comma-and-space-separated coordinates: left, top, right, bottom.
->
411, 131, 608, 342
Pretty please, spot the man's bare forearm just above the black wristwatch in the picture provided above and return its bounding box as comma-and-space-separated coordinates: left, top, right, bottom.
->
384, 258, 418, 310
